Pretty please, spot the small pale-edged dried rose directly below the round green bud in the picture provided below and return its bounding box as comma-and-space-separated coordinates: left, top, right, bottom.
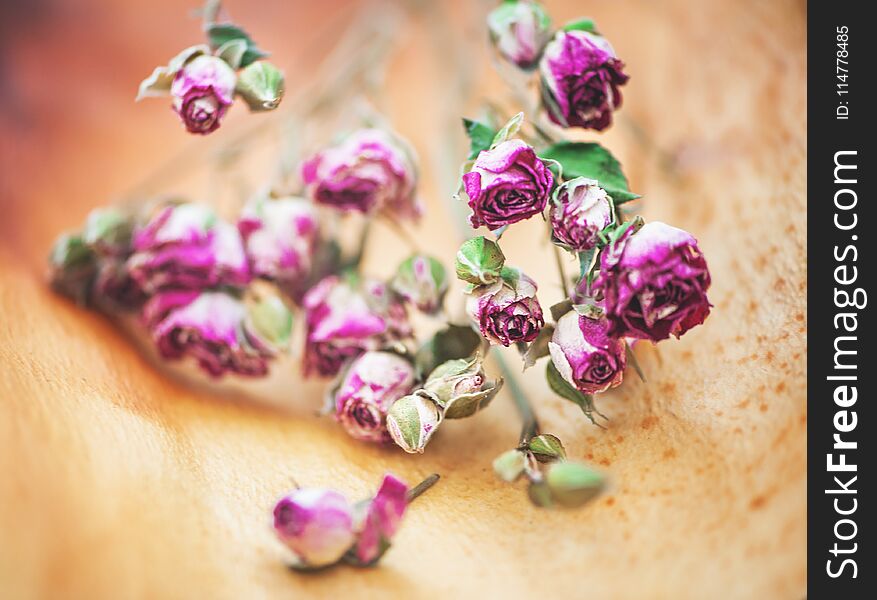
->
466, 267, 545, 346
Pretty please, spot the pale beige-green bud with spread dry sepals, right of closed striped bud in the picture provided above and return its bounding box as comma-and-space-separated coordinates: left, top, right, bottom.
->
423, 356, 502, 419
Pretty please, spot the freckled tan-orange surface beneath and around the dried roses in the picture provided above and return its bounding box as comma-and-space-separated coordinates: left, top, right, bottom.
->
0, 0, 807, 599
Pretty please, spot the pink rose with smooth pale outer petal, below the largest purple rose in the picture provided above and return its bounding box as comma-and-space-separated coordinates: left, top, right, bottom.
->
548, 310, 627, 394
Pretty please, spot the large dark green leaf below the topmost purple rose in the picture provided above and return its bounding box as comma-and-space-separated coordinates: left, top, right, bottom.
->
539, 142, 640, 206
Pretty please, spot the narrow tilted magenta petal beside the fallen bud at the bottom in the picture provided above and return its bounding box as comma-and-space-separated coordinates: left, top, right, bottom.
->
354, 474, 408, 566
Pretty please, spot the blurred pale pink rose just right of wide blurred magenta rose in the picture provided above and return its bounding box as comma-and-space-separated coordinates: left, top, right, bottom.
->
238, 198, 319, 285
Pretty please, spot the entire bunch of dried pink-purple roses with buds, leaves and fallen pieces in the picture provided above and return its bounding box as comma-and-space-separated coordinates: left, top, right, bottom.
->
51, 1, 710, 568
